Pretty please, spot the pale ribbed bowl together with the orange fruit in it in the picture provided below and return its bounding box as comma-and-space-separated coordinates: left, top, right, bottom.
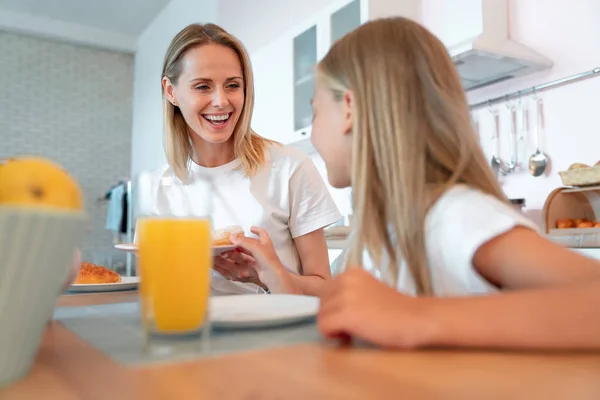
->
0, 157, 87, 387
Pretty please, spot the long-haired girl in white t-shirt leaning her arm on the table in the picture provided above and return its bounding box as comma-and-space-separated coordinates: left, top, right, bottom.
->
246, 18, 600, 349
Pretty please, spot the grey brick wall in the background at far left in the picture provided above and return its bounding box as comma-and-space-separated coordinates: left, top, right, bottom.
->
0, 32, 133, 263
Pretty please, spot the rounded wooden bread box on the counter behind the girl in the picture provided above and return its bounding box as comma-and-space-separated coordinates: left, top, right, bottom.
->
543, 186, 600, 248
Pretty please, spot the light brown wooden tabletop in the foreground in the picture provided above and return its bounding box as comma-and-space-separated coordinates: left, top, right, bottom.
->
0, 293, 600, 400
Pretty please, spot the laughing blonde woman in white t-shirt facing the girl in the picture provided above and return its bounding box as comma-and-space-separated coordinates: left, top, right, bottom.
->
151, 24, 341, 294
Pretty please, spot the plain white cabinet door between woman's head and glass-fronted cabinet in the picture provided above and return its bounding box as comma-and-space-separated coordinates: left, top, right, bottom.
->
250, 37, 294, 144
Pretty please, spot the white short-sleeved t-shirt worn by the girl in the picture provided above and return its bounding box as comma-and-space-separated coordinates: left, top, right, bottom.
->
356, 185, 539, 296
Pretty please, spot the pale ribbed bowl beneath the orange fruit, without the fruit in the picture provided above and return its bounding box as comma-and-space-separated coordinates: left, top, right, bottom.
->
0, 207, 87, 387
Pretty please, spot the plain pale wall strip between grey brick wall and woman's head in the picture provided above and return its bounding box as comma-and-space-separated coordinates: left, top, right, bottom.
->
131, 0, 218, 177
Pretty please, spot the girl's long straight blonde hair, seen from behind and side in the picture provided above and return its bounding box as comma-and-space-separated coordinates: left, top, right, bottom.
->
318, 18, 507, 295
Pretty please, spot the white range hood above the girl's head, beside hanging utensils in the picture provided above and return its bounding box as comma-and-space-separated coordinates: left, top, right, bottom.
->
438, 0, 553, 91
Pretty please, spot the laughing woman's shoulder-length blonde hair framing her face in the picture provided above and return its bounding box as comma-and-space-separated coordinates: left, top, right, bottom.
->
162, 24, 271, 182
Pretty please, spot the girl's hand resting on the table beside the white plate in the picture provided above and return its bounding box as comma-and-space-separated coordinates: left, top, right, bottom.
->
317, 268, 427, 349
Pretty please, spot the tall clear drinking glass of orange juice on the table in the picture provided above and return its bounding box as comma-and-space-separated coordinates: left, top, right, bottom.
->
136, 170, 213, 351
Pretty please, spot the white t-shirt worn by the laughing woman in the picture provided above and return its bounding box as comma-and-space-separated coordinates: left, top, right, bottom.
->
151, 145, 342, 293
